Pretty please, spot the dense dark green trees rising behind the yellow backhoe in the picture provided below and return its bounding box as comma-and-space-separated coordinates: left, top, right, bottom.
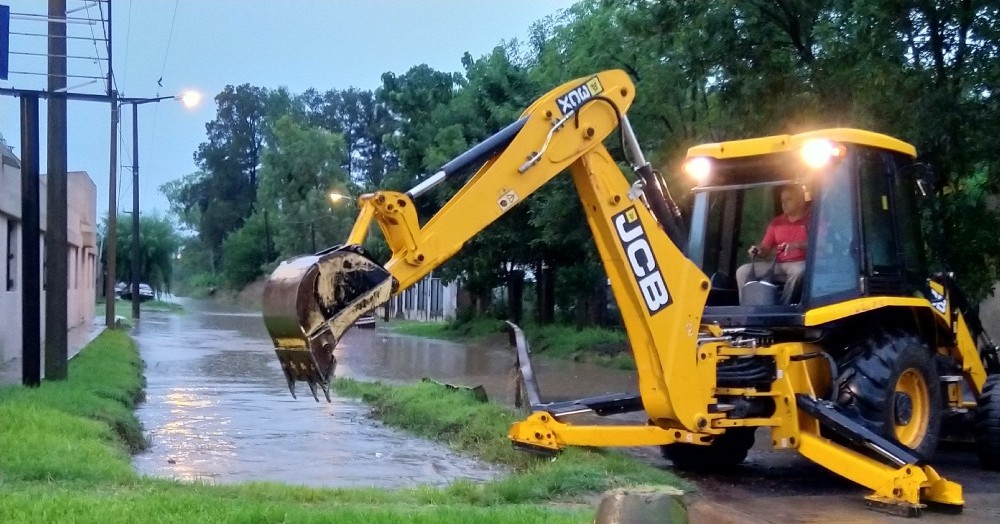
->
164, 0, 1000, 317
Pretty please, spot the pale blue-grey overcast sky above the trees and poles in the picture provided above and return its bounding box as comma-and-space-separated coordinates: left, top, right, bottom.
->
0, 0, 575, 217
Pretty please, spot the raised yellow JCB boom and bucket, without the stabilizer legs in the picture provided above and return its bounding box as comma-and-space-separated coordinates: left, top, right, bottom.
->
265, 71, 715, 430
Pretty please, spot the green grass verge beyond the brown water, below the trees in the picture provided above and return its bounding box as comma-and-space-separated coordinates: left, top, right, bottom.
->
389, 318, 635, 369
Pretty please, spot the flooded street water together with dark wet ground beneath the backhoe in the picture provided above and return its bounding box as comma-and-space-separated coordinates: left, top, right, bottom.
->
125, 301, 1000, 524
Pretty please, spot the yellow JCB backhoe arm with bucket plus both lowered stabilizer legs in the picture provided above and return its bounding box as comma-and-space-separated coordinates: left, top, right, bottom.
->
263, 71, 972, 511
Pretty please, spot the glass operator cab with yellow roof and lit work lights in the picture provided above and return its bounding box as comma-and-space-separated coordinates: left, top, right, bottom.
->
685, 129, 927, 327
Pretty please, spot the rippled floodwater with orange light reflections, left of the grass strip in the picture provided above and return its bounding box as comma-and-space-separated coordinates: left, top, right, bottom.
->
134, 302, 497, 488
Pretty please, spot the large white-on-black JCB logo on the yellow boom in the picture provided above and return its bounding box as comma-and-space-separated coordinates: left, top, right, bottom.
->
612, 207, 671, 315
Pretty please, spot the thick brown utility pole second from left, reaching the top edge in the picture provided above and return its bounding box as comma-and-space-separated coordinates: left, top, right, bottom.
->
45, 0, 69, 380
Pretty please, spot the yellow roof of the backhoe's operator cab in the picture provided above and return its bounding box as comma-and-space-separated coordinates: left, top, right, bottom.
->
687, 127, 917, 159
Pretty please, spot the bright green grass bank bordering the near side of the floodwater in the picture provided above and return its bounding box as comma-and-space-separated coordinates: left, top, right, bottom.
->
0, 331, 680, 524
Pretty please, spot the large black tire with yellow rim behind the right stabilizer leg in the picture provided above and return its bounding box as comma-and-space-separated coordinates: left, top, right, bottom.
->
838, 330, 944, 460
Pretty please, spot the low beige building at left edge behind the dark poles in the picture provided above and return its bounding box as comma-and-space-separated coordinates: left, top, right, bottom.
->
0, 137, 98, 382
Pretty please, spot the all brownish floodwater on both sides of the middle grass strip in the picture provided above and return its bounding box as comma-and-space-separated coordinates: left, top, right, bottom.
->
133, 301, 635, 488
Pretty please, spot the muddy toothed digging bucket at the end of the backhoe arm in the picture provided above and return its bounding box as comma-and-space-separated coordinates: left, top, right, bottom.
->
263, 245, 394, 401
